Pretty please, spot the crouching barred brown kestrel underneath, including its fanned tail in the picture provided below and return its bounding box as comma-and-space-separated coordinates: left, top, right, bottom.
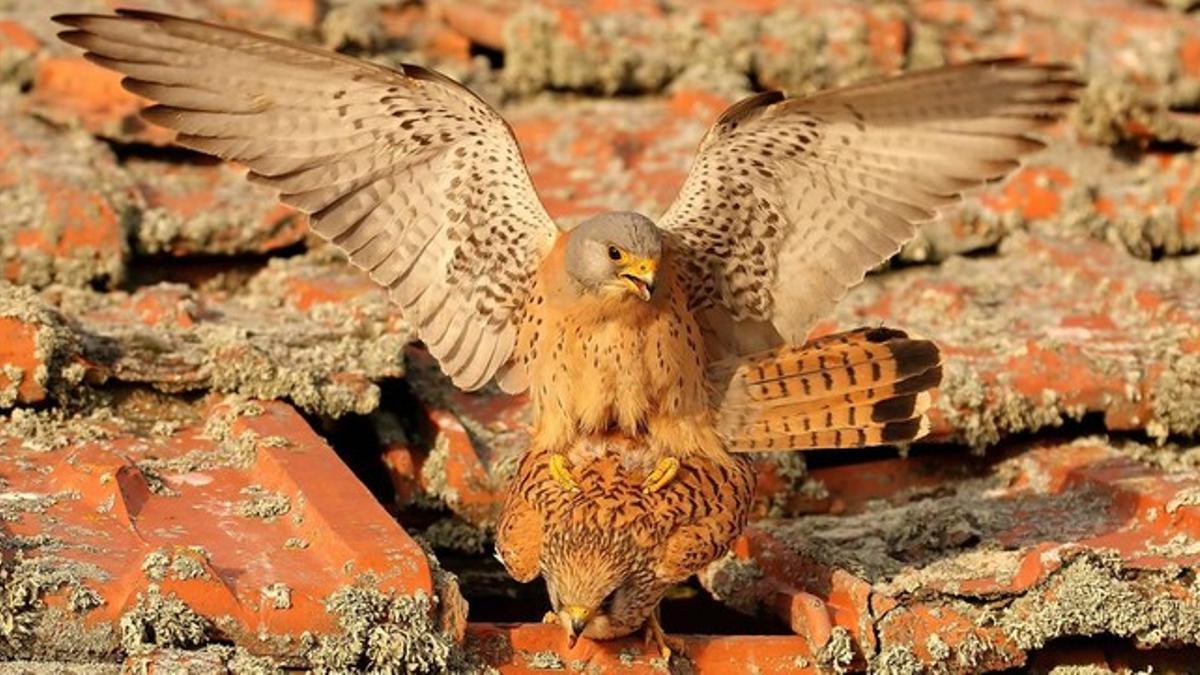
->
496, 328, 942, 656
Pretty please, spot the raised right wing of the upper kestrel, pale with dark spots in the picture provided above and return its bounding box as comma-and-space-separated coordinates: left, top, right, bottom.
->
660, 59, 1080, 356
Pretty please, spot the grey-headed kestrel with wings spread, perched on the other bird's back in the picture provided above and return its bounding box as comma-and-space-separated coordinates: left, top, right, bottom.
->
55, 10, 1080, 490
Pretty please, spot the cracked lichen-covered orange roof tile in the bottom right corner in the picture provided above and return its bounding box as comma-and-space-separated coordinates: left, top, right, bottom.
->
702, 438, 1200, 673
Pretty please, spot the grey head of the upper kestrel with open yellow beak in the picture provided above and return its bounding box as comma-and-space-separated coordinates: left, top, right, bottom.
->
566, 211, 662, 300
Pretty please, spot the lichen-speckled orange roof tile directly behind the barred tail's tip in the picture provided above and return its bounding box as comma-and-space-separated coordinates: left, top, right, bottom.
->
818, 234, 1200, 447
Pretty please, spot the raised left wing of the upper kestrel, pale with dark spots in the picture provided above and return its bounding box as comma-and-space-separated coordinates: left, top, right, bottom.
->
54, 10, 558, 389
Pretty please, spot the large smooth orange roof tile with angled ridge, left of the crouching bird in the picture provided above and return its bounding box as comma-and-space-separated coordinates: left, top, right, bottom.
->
0, 393, 463, 670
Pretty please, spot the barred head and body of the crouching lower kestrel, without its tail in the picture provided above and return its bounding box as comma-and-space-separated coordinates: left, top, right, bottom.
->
496, 435, 755, 657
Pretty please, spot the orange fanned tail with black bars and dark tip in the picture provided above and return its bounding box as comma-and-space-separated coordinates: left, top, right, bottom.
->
721, 328, 942, 452
